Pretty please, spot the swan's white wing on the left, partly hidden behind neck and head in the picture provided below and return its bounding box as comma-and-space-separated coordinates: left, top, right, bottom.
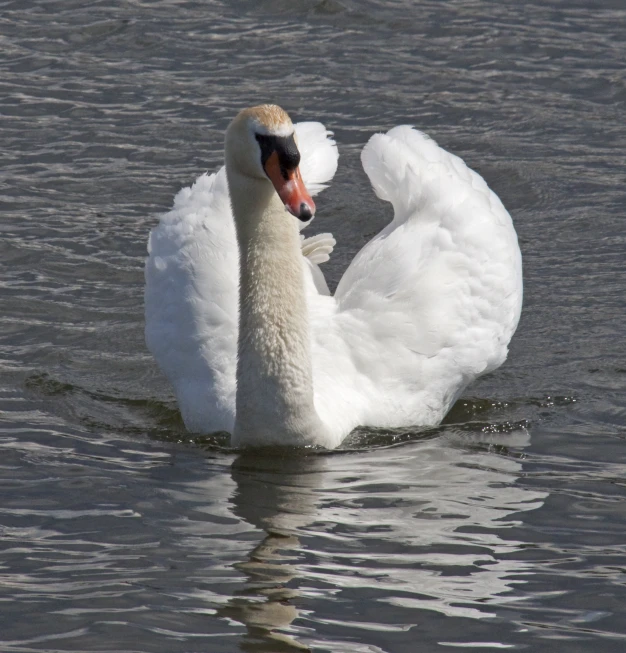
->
145, 123, 337, 432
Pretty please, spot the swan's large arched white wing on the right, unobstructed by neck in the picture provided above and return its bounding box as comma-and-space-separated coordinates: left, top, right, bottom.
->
311, 126, 522, 440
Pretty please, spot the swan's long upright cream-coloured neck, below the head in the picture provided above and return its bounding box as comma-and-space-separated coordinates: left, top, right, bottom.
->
227, 168, 324, 445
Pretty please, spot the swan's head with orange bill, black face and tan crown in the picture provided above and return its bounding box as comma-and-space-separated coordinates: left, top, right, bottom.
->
226, 104, 315, 222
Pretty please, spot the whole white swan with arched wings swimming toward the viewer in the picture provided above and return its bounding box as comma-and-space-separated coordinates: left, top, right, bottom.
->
145, 105, 522, 449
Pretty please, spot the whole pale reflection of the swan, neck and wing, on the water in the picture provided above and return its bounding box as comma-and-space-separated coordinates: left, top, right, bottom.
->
218, 432, 546, 651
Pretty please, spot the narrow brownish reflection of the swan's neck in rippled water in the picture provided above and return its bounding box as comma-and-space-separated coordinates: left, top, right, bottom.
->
218, 454, 327, 653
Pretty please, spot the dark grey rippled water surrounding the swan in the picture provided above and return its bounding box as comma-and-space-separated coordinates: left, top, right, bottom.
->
0, 0, 626, 653
